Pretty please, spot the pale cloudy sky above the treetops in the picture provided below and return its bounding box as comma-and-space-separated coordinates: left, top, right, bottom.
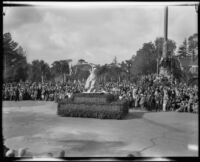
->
3, 2, 197, 65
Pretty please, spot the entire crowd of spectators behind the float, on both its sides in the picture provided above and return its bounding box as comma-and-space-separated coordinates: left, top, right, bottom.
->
3, 74, 198, 112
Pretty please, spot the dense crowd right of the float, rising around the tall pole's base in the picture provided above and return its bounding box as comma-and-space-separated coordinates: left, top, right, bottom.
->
112, 75, 198, 113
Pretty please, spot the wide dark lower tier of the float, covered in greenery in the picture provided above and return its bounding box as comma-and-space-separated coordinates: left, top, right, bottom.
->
57, 101, 128, 119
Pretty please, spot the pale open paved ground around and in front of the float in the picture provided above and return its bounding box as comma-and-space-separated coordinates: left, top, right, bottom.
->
3, 101, 198, 157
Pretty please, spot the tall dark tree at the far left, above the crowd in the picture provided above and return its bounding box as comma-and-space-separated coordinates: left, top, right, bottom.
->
3, 33, 28, 82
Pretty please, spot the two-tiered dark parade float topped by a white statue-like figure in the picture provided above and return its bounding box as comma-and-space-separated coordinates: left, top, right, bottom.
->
57, 65, 128, 119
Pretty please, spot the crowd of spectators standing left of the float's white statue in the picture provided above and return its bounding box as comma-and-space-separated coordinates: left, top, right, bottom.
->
3, 81, 84, 101
